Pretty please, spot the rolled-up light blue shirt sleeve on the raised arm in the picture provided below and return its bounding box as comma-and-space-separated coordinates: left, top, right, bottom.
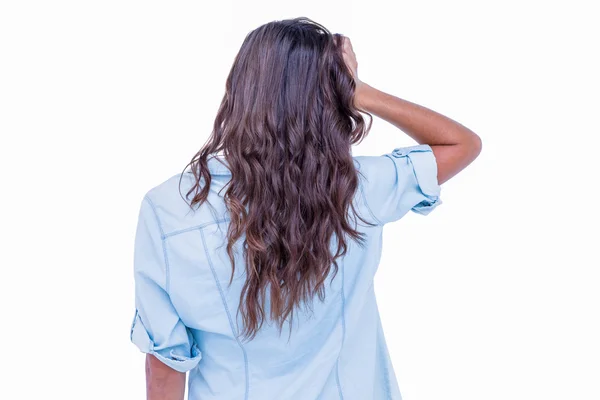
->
358, 144, 442, 224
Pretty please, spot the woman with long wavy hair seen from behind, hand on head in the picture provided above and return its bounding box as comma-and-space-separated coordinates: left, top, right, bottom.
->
131, 18, 481, 400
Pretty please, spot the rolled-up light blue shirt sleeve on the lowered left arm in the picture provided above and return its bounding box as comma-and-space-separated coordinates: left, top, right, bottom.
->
130, 196, 202, 372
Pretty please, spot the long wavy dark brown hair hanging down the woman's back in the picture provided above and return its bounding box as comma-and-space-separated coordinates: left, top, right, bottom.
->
180, 17, 372, 338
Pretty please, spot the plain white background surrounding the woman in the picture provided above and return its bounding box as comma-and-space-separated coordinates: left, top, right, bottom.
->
0, 0, 600, 400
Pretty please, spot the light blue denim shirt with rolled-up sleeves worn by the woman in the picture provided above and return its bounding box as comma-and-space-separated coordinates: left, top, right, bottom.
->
131, 145, 441, 400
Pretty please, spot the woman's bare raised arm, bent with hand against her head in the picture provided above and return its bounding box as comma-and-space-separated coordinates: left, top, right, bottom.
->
344, 37, 481, 184
